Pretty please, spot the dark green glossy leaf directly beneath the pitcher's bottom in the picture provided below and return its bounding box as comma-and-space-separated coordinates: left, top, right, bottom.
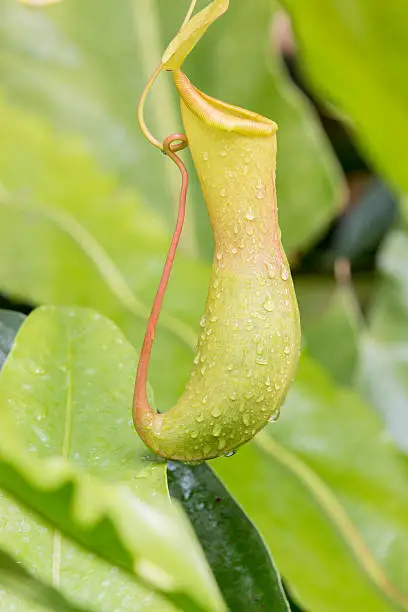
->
168, 463, 290, 612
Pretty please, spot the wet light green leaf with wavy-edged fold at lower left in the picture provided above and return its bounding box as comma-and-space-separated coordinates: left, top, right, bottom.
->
0, 307, 223, 612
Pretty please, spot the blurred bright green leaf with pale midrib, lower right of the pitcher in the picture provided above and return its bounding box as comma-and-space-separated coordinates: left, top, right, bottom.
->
211, 355, 408, 612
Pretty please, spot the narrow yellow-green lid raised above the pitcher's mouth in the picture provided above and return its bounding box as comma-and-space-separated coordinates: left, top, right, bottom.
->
162, 0, 229, 70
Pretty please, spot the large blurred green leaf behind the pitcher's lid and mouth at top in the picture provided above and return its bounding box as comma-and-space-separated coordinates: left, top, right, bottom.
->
0, 0, 340, 255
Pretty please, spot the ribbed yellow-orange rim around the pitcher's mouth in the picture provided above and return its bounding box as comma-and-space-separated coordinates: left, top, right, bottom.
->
173, 70, 278, 136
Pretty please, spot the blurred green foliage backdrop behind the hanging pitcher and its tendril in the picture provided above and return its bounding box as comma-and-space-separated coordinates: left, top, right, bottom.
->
0, 0, 408, 612
